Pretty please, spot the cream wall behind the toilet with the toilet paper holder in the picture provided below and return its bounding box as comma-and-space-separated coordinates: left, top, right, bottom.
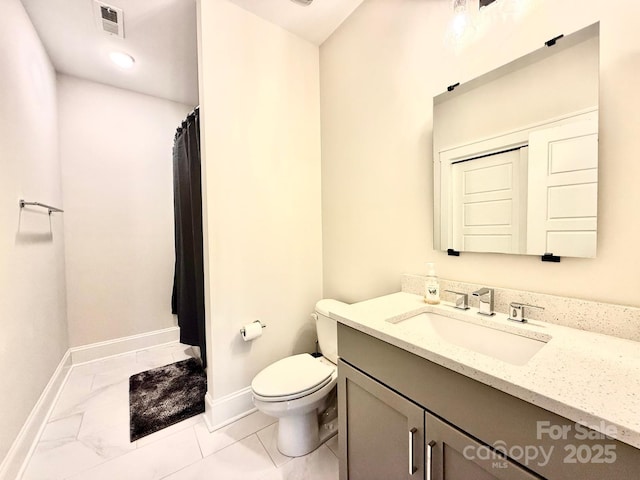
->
200, 0, 322, 399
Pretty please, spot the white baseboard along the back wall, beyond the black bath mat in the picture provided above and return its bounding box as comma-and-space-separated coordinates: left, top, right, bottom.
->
69, 327, 180, 365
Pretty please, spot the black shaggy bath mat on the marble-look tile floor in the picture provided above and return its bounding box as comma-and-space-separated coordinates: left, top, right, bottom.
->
129, 358, 207, 442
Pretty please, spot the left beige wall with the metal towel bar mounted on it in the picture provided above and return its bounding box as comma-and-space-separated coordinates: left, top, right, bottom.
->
0, 0, 67, 463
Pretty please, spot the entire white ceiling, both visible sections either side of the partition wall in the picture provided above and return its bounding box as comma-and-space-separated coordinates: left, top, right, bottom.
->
22, 0, 363, 105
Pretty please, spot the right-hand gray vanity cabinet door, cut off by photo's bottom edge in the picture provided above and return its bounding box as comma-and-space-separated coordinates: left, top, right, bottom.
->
425, 413, 542, 480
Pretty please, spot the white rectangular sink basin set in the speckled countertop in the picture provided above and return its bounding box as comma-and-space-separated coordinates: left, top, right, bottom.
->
390, 313, 548, 365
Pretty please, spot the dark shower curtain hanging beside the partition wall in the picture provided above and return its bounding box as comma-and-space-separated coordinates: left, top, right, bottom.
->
171, 108, 207, 367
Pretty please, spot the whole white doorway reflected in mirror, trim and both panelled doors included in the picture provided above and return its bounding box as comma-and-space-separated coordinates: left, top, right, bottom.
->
438, 108, 598, 257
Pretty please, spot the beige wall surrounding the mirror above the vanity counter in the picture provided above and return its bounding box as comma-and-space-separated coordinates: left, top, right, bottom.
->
320, 0, 640, 306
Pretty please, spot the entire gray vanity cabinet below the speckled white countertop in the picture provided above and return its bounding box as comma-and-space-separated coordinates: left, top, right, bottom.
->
338, 324, 640, 480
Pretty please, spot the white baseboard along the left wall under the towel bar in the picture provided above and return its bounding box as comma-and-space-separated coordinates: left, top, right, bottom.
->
0, 350, 72, 480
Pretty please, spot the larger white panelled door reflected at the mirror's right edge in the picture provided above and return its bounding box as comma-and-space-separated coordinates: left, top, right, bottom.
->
527, 117, 598, 257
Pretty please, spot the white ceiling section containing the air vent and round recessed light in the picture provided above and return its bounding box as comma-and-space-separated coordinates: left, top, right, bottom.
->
22, 0, 198, 105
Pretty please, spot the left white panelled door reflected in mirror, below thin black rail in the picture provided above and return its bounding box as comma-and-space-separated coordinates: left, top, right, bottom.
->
451, 147, 527, 253
